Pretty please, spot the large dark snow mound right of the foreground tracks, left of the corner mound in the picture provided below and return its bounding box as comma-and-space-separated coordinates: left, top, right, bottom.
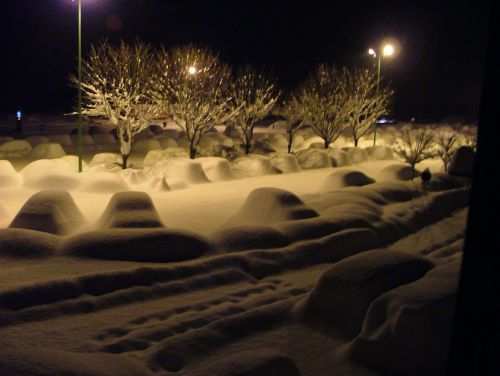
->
298, 249, 434, 337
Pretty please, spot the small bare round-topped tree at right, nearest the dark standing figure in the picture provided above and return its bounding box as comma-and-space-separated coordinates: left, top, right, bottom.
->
394, 125, 436, 179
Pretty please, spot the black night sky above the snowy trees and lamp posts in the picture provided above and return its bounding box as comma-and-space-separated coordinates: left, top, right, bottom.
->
0, 0, 490, 118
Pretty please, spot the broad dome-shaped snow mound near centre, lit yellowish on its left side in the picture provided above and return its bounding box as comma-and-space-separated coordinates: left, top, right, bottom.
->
223, 188, 318, 228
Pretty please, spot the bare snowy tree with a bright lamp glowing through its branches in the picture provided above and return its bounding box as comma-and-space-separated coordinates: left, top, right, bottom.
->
156, 45, 235, 159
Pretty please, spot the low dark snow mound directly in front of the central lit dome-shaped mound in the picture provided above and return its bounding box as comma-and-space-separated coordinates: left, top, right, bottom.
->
211, 226, 290, 252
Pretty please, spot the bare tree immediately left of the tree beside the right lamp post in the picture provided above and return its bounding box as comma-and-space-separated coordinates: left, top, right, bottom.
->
298, 64, 346, 149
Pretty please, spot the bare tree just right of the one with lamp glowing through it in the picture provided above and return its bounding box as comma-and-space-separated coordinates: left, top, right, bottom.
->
231, 65, 280, 154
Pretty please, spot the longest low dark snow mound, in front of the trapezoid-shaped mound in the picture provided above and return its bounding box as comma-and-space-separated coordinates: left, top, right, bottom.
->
63, 228, 213, 262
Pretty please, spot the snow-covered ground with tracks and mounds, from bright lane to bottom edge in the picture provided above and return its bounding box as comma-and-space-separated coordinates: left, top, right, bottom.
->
0, 146, 468, 376
